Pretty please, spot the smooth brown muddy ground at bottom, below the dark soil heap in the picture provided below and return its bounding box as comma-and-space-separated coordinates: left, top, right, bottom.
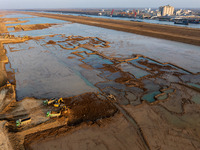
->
27, 114, 148, 150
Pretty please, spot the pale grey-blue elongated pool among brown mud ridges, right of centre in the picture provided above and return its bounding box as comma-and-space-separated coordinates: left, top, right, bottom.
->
118, 63, 150, 79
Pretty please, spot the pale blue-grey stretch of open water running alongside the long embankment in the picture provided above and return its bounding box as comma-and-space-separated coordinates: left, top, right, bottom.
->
12, 24, 200, 73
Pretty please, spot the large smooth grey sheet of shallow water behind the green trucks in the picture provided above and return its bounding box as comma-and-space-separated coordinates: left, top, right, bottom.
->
5, 37, 98, 99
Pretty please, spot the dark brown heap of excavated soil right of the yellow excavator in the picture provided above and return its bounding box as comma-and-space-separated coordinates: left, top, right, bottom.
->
64, 93, 117, 125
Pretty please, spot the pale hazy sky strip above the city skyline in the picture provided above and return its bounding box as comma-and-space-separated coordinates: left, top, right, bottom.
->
0, 0, 200, 9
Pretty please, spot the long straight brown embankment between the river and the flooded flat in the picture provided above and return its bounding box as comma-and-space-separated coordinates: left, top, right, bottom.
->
10, 11, 200, 46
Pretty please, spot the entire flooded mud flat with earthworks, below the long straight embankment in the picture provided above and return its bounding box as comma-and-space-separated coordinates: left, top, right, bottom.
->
0, 14, 200, 150
